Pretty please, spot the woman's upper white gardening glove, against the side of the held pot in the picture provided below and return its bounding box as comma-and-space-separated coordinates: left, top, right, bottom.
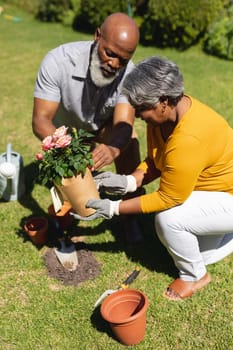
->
94, 171, 137, 194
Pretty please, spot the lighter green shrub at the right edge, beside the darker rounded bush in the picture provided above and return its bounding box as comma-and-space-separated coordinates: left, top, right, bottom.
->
203, 5, 233, 60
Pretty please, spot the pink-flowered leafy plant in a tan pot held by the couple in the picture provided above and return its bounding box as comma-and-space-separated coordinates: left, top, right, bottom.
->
36, 126, 99, 216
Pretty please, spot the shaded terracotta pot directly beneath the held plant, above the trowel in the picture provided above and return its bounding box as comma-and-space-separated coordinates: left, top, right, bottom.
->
48, 201, 73, 230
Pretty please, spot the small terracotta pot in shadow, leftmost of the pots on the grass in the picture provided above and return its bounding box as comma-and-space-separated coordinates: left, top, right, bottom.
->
24, 216, 48, 245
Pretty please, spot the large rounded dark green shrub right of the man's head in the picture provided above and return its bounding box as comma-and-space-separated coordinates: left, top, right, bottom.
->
141, 0, 229, 49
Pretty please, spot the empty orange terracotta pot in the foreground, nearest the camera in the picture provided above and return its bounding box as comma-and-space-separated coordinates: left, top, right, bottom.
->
100, 289, 149, 345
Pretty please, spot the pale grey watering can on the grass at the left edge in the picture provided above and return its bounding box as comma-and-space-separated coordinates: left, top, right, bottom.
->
0, 143, 25, 201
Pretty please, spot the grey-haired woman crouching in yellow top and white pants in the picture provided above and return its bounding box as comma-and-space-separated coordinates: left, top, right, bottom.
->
72, 57, 233, 300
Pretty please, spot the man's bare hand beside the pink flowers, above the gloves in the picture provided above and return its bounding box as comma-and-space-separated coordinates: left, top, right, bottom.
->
92, 143, 120, 170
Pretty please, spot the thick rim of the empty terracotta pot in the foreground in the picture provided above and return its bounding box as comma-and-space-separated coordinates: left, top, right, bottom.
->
100, 288, 149, 324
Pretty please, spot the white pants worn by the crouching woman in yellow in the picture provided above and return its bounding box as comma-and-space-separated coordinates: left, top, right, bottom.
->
155, 191, 233, 281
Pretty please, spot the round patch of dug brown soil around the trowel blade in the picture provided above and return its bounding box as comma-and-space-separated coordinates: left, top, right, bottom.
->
43, 244, 101, 286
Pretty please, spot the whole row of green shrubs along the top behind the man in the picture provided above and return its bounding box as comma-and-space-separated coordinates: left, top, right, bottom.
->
6, 0, 233, 60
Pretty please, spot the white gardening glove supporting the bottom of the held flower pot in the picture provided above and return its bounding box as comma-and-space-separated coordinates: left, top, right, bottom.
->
70, 199, 121, 221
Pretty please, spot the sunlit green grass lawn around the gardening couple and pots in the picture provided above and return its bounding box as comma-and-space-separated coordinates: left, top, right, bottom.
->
0, 6, 233, 350
